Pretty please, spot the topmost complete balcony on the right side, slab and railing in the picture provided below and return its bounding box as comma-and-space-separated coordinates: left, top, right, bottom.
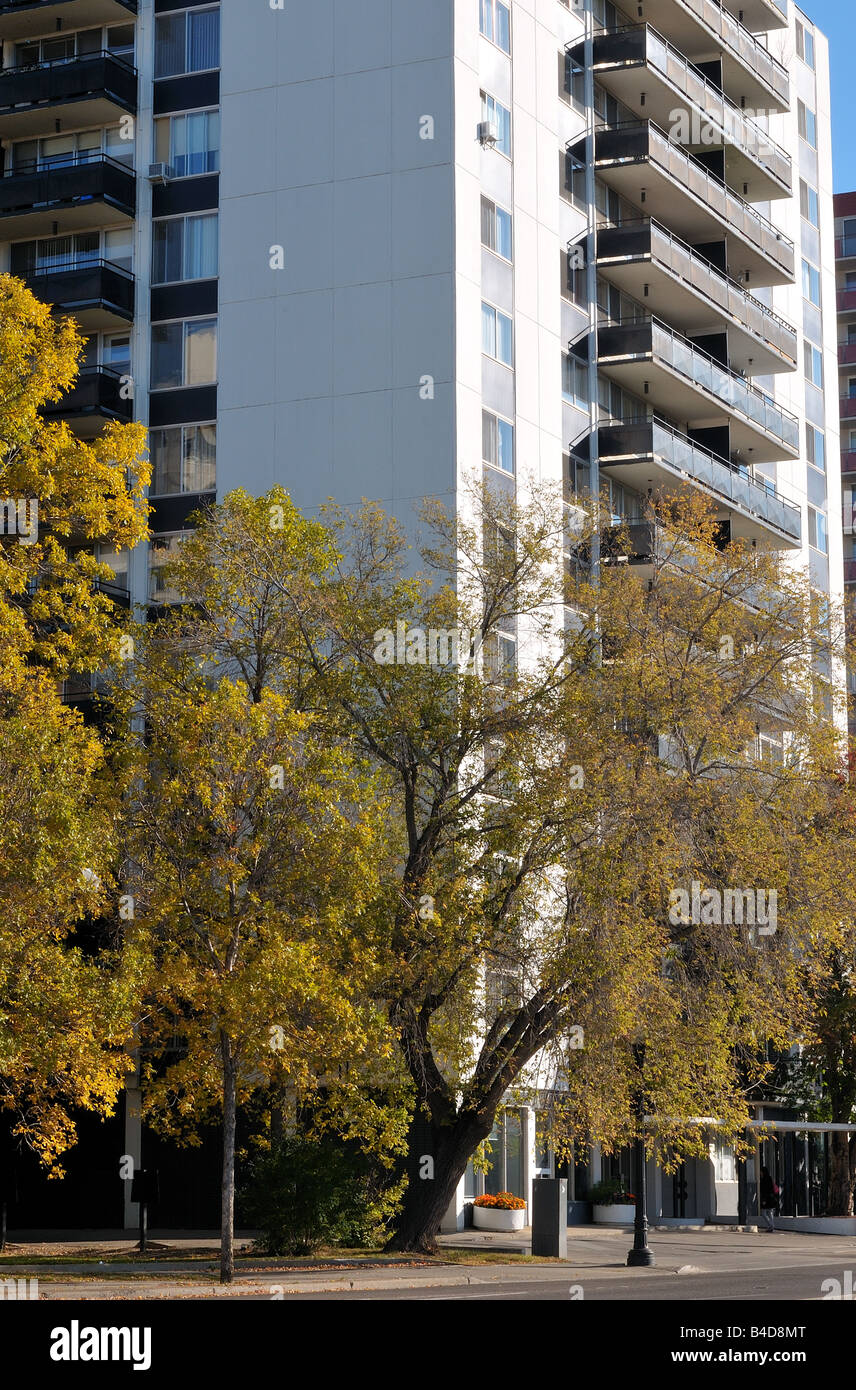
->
574, 24, 792, 203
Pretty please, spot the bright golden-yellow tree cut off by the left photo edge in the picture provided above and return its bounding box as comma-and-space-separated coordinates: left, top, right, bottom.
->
0, 275, 147, 1165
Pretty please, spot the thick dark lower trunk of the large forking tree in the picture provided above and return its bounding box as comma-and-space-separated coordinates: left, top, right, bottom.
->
386, 1112, 493, 1255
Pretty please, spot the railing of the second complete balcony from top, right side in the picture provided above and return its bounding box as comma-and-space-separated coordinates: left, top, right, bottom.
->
595, 121, 793, 279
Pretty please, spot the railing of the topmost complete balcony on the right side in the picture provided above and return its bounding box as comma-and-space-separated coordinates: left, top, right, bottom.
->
593, 24, 792, 193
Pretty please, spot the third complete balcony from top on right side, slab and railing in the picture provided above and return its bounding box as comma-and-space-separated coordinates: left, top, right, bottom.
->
598, 218, 798, 377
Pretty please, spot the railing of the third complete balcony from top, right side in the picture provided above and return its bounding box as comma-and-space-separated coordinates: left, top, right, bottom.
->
598, 217, 798, 364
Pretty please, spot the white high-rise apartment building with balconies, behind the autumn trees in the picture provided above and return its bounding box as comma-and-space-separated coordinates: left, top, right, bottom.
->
0, 8, 856, 1219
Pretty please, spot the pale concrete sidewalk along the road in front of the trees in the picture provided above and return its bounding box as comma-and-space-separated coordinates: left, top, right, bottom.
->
0, 1226, 856, 1301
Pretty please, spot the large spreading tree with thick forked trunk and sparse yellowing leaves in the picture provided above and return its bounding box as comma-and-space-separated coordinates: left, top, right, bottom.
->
269, 478, 844, 1251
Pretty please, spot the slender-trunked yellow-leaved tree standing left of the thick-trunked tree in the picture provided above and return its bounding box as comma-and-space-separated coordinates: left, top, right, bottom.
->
117, 495, 386, 1283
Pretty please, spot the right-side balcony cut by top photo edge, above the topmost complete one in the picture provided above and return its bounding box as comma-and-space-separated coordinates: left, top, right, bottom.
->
614, 0, 791, 111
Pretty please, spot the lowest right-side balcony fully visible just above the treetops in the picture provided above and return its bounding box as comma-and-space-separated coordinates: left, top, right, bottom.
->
598, 417, 802, 548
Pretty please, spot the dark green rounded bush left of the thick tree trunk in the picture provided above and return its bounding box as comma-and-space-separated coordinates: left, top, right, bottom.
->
240, 1134, 402, 1255
